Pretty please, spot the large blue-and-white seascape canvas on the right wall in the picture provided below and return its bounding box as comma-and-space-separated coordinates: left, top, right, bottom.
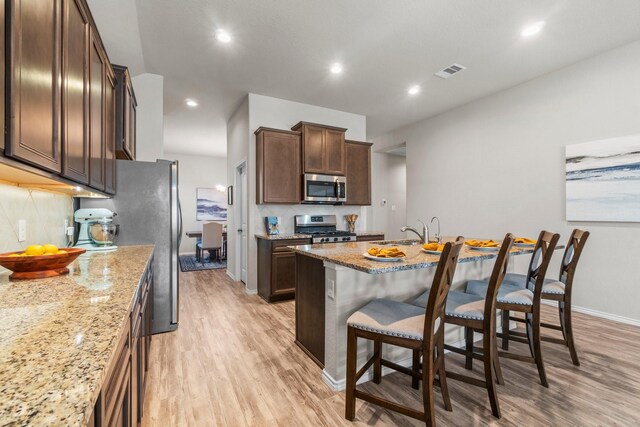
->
565, 134, 640, 222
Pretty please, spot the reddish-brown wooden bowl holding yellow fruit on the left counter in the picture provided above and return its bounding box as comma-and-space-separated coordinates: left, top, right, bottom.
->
0, 248, 86, 280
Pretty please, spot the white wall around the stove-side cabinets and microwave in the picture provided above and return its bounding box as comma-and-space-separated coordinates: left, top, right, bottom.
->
227, 94, 369, 292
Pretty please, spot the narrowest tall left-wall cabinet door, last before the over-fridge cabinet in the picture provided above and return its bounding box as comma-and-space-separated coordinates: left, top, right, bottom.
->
104, 66, 116, 194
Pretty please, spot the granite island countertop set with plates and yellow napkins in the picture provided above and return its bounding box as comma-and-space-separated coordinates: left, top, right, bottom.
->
291, 237, 533, 274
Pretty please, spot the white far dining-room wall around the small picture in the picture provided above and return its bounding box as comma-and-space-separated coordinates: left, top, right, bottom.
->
164, 153, 227, 254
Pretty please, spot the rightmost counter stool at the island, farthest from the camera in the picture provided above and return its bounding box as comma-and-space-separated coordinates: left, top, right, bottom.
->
504, 228, 589, 366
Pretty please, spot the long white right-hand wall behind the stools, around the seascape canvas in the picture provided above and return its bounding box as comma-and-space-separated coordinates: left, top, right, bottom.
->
372, 42, 640, 321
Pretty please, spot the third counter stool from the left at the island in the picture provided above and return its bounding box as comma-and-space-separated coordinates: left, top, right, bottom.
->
466, 230, 560, 387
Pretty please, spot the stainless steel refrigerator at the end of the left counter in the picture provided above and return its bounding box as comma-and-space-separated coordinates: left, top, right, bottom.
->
80, 160, 182, 334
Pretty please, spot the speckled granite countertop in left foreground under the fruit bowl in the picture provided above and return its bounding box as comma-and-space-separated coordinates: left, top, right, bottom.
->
0, 245, 153, 426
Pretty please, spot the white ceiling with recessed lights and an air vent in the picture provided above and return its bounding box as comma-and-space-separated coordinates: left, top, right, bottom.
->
89, 0, 640, 156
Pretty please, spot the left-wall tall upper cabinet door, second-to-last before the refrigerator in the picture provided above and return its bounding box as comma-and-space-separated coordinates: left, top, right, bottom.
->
89, 30, 106, 191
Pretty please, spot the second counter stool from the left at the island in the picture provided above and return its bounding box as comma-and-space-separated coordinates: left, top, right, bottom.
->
413, 233, 515, 418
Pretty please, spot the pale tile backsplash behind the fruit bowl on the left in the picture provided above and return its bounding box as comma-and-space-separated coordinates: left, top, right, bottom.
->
0, 183, 73, 260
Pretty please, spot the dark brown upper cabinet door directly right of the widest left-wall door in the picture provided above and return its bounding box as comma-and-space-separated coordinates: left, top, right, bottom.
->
62, 0, 90, 184
